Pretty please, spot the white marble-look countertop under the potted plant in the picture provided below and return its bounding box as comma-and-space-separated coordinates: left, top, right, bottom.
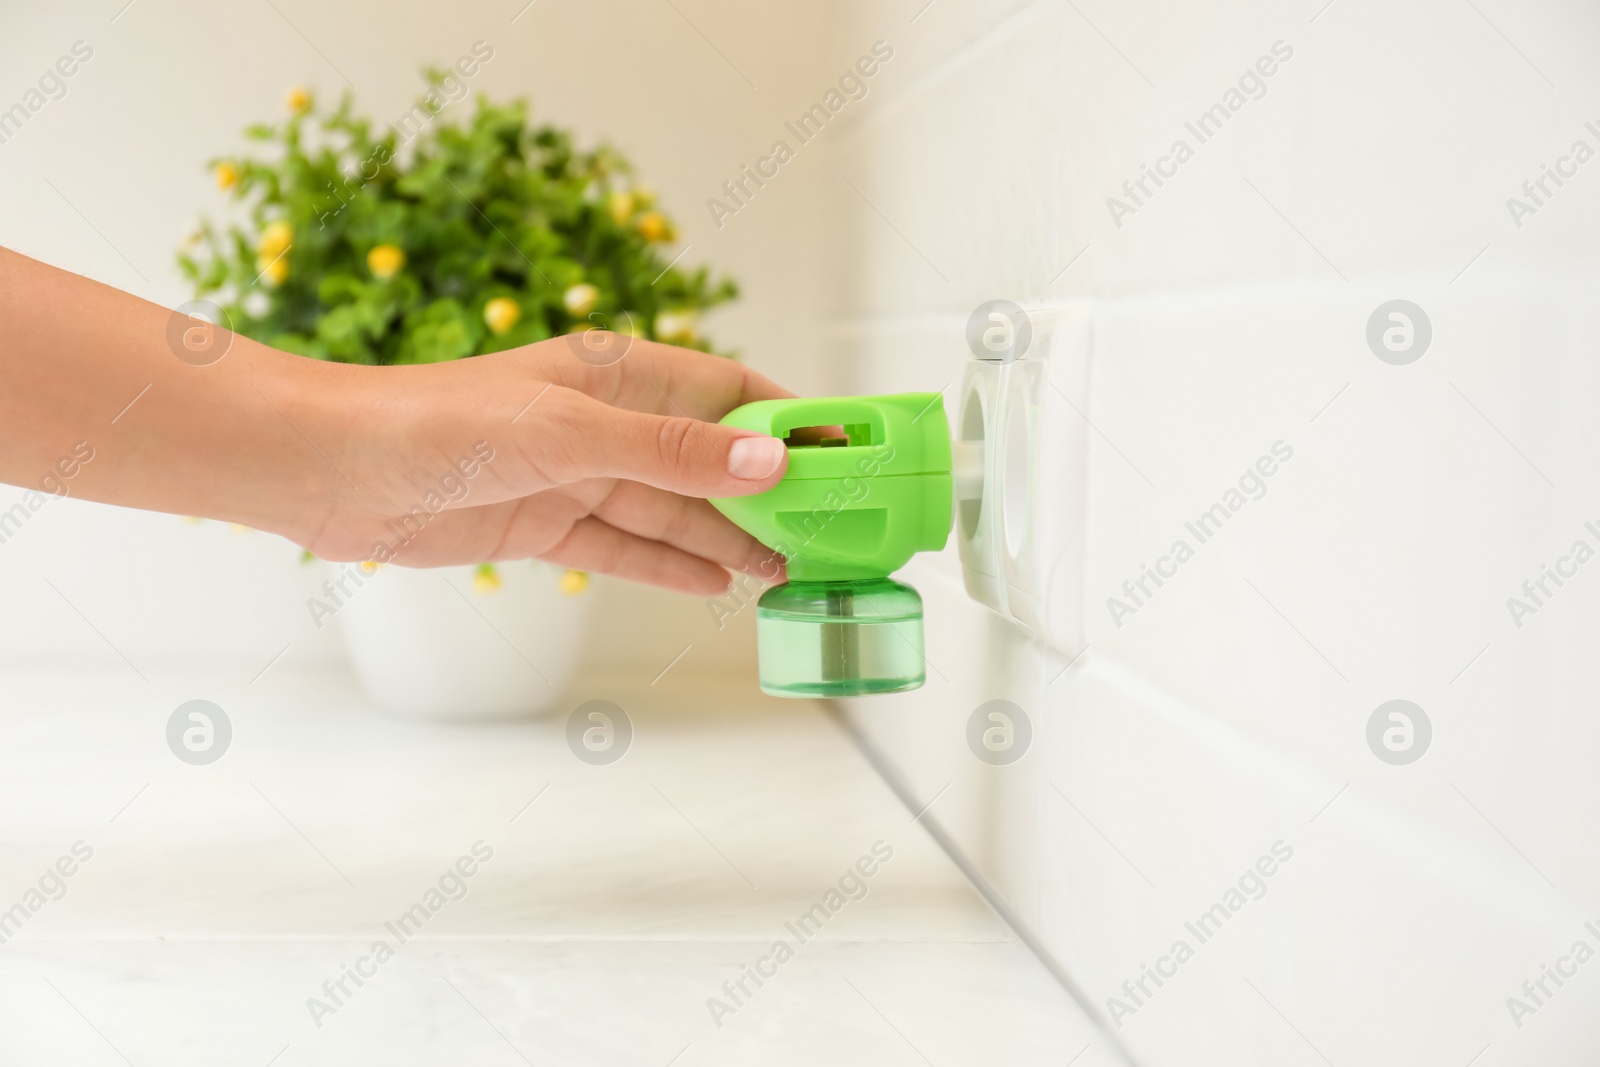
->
0, 670, 1118, 1067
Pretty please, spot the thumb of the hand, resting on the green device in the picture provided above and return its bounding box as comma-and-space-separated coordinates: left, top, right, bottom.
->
552, 392, 789, 498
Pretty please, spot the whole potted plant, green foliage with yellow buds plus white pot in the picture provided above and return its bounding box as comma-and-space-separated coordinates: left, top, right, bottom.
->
179, 79, 738, 717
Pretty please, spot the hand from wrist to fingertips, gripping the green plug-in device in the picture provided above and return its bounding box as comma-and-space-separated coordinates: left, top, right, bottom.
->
292, 336, 789, 595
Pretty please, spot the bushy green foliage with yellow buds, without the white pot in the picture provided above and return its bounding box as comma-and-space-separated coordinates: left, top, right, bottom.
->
187, 81, 738, 365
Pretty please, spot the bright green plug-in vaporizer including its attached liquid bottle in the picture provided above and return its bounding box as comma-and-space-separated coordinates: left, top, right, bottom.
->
712, 394, 952, 696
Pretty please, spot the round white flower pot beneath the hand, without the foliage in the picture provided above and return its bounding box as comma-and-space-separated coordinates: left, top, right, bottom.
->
338, 561, 595, 720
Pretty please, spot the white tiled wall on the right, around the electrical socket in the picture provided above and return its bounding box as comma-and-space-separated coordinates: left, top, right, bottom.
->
832, 0, 1600, 1067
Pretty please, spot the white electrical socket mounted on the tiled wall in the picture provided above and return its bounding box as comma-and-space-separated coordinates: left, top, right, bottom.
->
955, 304, 1091, 656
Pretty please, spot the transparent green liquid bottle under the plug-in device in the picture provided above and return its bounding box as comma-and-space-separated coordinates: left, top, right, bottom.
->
755, 577, 926, 697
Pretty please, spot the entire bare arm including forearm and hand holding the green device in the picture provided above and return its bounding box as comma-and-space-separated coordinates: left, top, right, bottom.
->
0, 250, 787, 593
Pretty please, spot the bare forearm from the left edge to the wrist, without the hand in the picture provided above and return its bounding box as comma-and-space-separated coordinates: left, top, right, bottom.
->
0, 250, 339, 541
